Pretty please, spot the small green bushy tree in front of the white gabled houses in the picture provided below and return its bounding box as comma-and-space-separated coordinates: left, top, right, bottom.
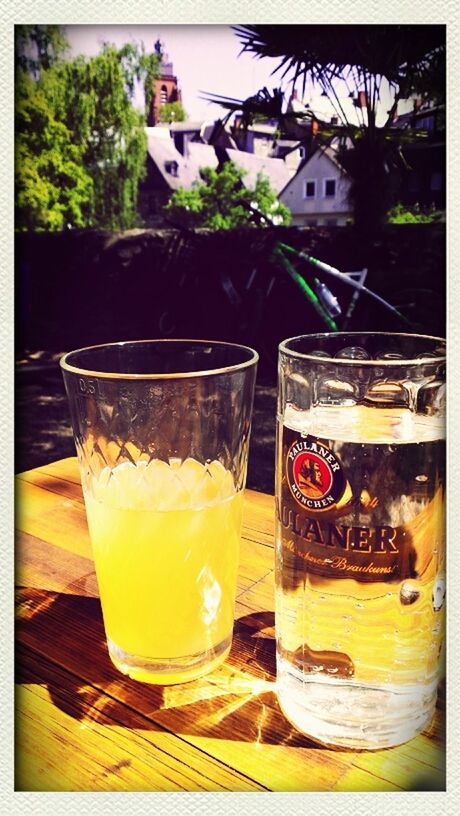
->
165, 161, 291, 230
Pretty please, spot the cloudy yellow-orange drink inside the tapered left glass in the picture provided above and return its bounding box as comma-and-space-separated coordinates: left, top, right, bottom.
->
85, 459, 242, 683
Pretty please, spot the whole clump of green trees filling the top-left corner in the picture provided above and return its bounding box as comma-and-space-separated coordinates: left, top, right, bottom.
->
16, 27, 162, 230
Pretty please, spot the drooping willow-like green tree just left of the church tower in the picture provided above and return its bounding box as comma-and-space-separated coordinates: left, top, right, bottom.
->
45, 44, 153, 229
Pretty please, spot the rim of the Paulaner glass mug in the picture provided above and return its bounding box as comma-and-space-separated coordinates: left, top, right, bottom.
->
278, 331, 446, 368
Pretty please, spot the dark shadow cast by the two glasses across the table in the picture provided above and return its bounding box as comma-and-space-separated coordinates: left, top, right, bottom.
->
16, 585, 320, 748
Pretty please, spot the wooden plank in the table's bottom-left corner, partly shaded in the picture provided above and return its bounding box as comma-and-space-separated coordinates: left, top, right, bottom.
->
16, 650, 263, 791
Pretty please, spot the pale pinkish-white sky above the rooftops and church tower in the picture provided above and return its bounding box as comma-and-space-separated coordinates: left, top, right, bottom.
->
65, 23, 412, 125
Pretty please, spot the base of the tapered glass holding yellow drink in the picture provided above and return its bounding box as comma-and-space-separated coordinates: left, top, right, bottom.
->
107, 636, 232, 685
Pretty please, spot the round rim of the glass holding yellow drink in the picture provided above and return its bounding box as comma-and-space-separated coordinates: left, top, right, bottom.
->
59, 337, 259, 380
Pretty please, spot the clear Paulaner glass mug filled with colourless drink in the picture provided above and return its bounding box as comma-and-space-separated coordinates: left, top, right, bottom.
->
276, 333, 445, 749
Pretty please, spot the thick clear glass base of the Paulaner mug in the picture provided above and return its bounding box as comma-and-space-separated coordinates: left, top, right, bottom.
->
277, 661, 437, 751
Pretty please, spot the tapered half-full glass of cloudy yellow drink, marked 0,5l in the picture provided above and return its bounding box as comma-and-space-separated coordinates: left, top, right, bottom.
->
61, 340, 258, 683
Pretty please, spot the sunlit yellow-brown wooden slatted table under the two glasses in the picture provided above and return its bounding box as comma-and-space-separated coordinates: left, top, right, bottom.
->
16, 458, 445, 791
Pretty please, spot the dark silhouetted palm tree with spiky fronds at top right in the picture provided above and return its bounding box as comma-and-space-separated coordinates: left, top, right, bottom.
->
207, 25, 445, 231
